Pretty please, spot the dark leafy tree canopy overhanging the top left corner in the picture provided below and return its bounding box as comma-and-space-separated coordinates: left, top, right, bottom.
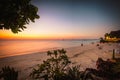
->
0, 0, 39, 33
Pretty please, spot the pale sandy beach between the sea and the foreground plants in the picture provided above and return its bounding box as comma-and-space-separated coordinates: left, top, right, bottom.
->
0, 43, 120, 80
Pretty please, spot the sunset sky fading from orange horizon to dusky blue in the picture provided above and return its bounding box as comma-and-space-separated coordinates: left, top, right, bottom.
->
0, 0, 120, 39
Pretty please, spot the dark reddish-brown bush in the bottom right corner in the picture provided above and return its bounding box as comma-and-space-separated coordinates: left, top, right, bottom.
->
83, 58, 120, 80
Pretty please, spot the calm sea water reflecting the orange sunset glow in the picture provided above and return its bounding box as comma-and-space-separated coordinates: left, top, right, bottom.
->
0, 39, 98, 58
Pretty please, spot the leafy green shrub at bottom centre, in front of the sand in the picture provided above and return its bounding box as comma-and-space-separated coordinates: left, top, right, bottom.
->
30, 49, 71, 80
